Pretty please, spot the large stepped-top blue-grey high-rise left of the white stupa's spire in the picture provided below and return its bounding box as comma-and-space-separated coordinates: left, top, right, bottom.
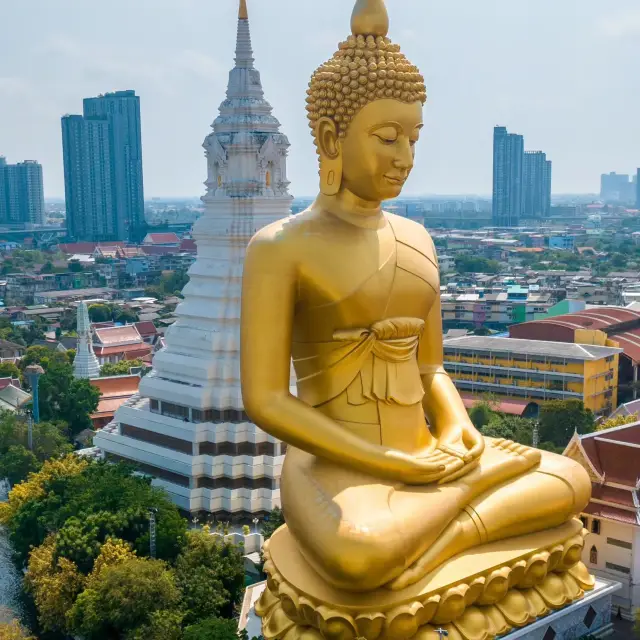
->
62, 91, 144, 242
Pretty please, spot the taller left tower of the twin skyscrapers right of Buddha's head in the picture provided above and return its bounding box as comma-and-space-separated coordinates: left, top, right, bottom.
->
493, 127, 524, 227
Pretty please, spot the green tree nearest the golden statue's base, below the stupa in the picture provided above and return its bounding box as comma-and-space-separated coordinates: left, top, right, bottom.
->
175, 528, 244, 623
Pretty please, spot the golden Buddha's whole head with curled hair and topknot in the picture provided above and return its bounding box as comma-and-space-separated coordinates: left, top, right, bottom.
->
307, 0, 427, 203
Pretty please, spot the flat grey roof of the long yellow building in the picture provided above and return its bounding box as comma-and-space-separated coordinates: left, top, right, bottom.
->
444, 336, 622, 360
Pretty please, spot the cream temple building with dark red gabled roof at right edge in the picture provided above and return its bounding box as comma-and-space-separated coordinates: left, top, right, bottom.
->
564, 423, 640, 620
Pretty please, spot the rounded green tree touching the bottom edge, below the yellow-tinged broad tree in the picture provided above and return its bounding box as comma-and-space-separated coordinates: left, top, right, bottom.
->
68, 558, 180, 640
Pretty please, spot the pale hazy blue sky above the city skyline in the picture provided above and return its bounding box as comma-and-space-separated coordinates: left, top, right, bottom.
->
0, 0, 640, 198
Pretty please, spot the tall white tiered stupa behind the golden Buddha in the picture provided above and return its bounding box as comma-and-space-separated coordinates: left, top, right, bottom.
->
94, 0, 292, 521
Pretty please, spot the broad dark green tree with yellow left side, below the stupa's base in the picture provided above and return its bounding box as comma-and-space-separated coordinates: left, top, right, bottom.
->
0, 456, 186, 570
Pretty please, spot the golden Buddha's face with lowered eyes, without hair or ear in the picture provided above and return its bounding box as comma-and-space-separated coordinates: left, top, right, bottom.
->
340, 99, 423, 202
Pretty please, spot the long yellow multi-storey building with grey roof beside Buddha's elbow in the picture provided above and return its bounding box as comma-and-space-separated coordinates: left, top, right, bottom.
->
444, 336, 622, 416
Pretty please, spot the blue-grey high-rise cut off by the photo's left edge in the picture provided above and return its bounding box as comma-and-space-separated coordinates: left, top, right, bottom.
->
0, 157, 45, 225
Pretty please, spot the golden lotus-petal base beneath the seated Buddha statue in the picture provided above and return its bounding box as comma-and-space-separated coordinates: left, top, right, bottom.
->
256, 520, 595, 640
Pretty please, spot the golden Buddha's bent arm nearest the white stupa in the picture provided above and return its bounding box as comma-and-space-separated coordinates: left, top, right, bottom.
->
241, 229, 430, 479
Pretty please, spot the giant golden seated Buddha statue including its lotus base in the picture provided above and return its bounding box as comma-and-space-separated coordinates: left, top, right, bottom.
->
241, 0, 593, 640
